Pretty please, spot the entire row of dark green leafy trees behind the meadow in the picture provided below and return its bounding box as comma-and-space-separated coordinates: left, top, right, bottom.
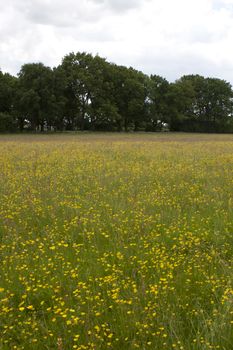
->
0, 52, 233, 132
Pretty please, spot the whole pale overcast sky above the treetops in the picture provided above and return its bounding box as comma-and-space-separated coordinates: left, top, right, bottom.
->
0, 0, 233, 85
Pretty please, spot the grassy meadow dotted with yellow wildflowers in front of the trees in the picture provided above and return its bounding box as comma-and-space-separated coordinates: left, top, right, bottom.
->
0, 134, 233, 350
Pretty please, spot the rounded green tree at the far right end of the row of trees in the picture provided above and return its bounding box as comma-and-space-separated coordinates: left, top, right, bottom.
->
169, 75, 233, 132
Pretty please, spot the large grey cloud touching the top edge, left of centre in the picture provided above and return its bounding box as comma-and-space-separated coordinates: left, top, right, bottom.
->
7, 0, 144, 27
